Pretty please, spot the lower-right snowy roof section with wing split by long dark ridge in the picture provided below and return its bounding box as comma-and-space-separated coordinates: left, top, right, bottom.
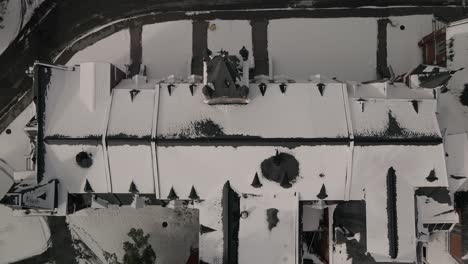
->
350, 144, 448, 262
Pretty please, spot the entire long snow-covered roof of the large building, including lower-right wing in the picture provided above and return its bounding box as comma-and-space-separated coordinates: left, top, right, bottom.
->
33, 63, 453, 261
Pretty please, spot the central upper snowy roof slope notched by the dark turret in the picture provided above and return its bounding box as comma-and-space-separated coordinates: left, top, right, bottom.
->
157, 83, 348, 139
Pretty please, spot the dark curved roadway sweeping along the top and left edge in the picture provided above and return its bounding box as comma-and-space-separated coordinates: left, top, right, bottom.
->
0, 0, 467, 133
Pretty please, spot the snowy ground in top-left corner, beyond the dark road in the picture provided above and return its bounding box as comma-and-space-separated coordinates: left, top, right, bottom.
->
0, 0, 44, 54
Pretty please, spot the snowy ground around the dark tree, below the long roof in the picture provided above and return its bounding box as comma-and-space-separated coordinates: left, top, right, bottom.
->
68, 206, 199, 263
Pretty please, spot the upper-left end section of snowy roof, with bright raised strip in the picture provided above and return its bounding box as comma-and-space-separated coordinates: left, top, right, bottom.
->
40, 63, 111, 138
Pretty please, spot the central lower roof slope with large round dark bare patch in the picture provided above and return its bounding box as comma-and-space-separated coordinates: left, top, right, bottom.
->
157, 145, 349, 200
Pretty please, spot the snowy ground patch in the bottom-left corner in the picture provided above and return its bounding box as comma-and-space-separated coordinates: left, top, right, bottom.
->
0, 205, 50, 263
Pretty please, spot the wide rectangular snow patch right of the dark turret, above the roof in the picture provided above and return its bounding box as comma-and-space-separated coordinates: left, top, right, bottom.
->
268, 18, 376, 81
